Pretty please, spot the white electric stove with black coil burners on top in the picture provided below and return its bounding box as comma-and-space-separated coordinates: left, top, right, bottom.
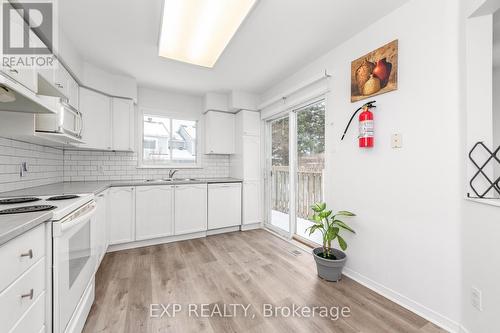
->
0, 193, 99, 333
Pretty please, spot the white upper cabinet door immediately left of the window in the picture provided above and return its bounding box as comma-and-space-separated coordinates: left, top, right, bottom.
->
112, 98, 135, 151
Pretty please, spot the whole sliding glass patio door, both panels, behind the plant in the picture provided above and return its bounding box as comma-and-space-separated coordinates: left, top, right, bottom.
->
266, 100, 325, 243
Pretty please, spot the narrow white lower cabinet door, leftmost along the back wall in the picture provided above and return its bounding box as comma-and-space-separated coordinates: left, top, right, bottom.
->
108, 187, 135, 245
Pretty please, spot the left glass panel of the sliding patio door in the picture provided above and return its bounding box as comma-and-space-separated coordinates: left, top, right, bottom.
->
269, 117, 290, 232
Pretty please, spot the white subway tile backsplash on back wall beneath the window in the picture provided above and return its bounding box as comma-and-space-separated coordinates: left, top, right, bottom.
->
64, 150, 229, 181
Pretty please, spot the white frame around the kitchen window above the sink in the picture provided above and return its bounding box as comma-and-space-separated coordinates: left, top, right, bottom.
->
136, 108, 202, 169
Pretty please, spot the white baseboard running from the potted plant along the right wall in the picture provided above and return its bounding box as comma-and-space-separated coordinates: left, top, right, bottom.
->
343, 268, 460, 333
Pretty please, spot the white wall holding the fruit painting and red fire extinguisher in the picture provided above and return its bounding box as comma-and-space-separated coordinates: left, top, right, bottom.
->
263, 0, 463, 330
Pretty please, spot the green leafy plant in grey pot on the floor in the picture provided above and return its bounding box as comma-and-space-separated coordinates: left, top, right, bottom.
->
306, 203, 356, 281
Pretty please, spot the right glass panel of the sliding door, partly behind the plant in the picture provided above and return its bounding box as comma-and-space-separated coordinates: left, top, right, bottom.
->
296, 101, 325, 244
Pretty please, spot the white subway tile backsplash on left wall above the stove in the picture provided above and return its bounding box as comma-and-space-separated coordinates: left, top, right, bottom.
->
0, 138, 64, 192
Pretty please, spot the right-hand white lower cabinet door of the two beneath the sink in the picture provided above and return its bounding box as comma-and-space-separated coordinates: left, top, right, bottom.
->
174, 184, 207, 235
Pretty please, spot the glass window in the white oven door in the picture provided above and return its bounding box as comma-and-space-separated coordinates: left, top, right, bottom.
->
68, 221, 91, 289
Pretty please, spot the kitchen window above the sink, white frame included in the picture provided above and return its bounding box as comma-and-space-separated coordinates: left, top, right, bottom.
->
140, 113, 198, 168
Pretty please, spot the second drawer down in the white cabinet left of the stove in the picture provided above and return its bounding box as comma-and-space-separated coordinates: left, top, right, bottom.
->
0, 258, 45, 332
